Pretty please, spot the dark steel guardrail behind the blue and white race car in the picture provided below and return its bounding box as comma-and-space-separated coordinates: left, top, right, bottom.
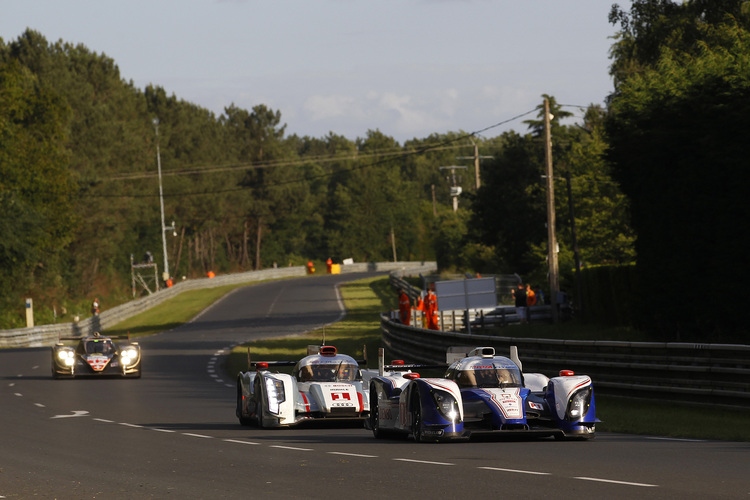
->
380, 314, 750, 408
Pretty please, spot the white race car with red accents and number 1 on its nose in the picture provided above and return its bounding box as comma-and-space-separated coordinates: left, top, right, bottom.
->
236, 345, 377, 427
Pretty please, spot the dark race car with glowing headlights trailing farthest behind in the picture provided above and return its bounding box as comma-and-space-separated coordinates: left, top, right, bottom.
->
52, 332, 141, 378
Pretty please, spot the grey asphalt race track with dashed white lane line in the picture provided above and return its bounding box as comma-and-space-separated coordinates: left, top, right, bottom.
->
0, 275, 750, 500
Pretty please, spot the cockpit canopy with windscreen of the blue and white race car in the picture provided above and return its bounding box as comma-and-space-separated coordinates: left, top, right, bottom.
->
445, 357, 523, 389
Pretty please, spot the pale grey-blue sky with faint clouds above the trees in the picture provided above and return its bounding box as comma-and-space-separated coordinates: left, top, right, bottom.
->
0, 0, 630, 143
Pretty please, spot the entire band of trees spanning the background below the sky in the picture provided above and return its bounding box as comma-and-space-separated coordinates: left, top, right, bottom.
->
5, 0, 750, 342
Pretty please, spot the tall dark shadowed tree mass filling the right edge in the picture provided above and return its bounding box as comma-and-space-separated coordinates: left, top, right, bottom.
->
606, 0, 750, 343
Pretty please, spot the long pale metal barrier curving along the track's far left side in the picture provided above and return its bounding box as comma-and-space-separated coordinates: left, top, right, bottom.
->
0, 262, 437, 348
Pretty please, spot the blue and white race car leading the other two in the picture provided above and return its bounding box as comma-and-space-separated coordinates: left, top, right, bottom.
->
366, 347, 598, 441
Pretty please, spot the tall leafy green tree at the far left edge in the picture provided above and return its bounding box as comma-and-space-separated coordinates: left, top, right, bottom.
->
0, 60, 76, 316
